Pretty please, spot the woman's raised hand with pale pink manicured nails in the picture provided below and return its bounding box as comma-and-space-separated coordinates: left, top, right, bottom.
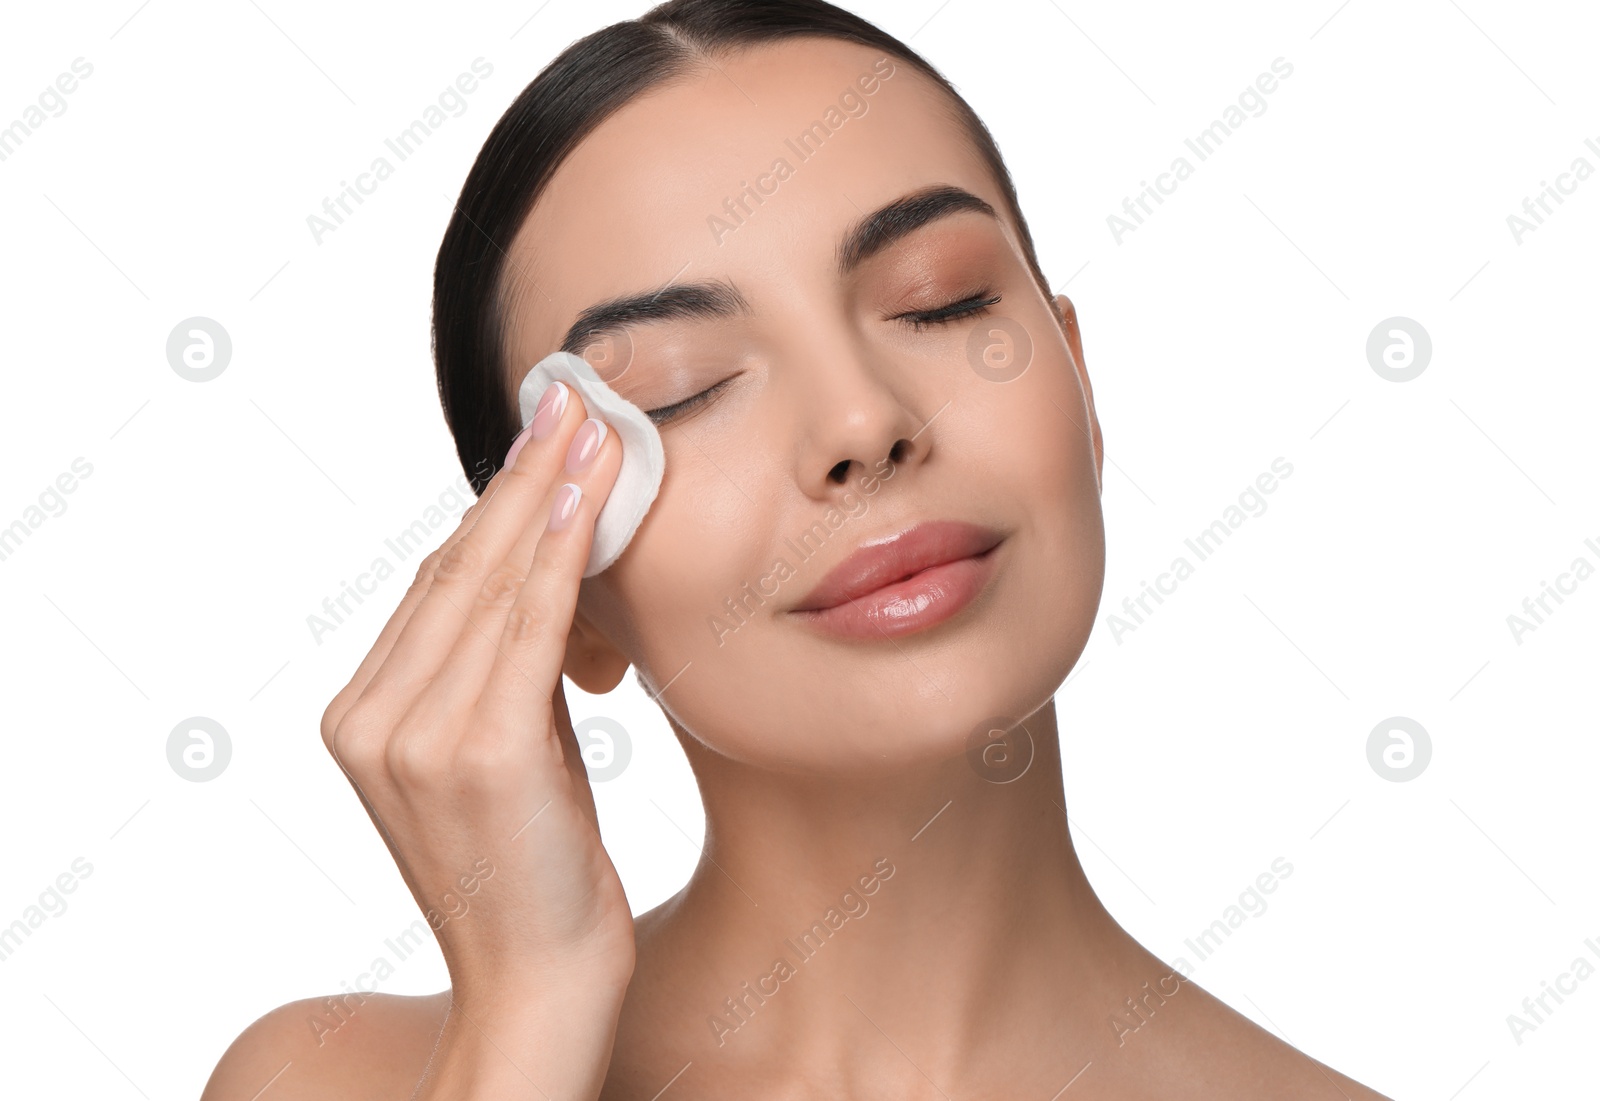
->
322, 377, 634, 1015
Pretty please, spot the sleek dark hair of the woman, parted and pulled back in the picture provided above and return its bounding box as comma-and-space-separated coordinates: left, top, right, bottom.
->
434, 0, 1053, 493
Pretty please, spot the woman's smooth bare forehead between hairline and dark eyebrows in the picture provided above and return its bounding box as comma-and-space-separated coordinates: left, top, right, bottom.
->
506, 37, 1002, 364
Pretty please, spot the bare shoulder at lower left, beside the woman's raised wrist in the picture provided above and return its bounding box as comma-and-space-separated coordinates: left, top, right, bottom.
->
200, 991, 450, 1101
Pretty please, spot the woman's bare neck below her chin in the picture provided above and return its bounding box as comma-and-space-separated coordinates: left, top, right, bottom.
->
620, 703, 1165, 1096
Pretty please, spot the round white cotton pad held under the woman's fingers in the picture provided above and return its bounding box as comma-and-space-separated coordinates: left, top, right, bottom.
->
517, 352, 666, 578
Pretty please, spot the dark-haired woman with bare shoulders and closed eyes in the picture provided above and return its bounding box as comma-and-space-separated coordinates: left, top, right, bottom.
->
205, 0, 1381, 1101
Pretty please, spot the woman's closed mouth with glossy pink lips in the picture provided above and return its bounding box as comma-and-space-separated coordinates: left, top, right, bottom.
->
789, 520, 1005, 639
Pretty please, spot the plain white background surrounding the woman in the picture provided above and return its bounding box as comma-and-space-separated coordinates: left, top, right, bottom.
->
0, 0, 1600, 1101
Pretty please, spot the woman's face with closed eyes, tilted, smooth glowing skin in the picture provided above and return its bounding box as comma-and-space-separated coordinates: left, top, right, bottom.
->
507, 38, 1104, 776
